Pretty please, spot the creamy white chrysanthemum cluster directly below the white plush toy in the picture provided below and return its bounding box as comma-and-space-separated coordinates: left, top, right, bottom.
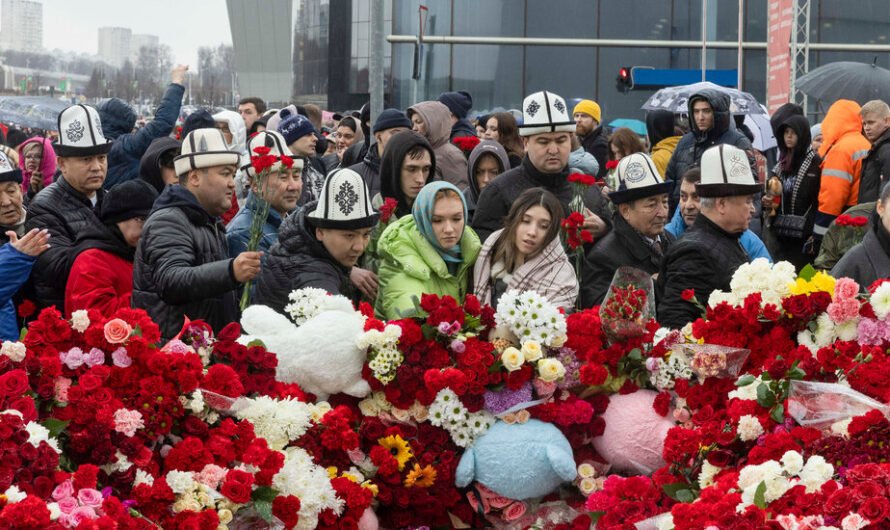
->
235, 396, 312, 450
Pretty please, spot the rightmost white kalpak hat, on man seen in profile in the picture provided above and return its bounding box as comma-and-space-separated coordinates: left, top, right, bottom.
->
695, 144, 761, 197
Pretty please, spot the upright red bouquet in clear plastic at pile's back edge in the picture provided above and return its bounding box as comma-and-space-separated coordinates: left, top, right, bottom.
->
600, 267, 655, 342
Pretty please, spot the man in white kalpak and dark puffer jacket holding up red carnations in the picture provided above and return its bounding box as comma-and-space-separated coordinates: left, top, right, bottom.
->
133, 129, 261, 340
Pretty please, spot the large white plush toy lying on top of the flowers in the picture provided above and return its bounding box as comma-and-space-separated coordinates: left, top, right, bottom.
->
238, 296, 371, 400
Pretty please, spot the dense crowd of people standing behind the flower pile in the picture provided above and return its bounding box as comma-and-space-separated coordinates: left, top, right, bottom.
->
0, 60, 890, 340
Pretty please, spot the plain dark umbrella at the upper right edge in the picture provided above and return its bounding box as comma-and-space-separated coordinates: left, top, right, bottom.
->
797, 58, 890, 105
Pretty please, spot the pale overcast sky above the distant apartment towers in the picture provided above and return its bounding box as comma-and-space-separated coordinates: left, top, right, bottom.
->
42, 0, 232, 69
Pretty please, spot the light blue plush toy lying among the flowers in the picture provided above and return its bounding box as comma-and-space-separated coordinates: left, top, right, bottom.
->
455, 420, 577, 500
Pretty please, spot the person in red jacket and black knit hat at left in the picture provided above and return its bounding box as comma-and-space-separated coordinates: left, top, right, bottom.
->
65, 179, 158, 316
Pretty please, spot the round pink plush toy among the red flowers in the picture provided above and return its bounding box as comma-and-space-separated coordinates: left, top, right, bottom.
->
593, 390, 675, 475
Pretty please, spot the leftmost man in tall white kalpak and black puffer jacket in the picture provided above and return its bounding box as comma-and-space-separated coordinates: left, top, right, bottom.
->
25, 105, 111, 313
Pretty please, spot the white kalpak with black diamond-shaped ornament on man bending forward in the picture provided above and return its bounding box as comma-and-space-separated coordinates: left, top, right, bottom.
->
307, 168, 380, 230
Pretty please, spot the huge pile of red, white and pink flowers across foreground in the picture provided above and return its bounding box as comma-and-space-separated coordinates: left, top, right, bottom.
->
8, 255, 890, 530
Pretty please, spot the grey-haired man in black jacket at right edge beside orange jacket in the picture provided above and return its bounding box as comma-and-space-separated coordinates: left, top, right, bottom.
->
859, 99, 890, 204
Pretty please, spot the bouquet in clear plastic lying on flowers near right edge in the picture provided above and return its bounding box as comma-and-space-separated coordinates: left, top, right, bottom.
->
788, 381, 890, 432
